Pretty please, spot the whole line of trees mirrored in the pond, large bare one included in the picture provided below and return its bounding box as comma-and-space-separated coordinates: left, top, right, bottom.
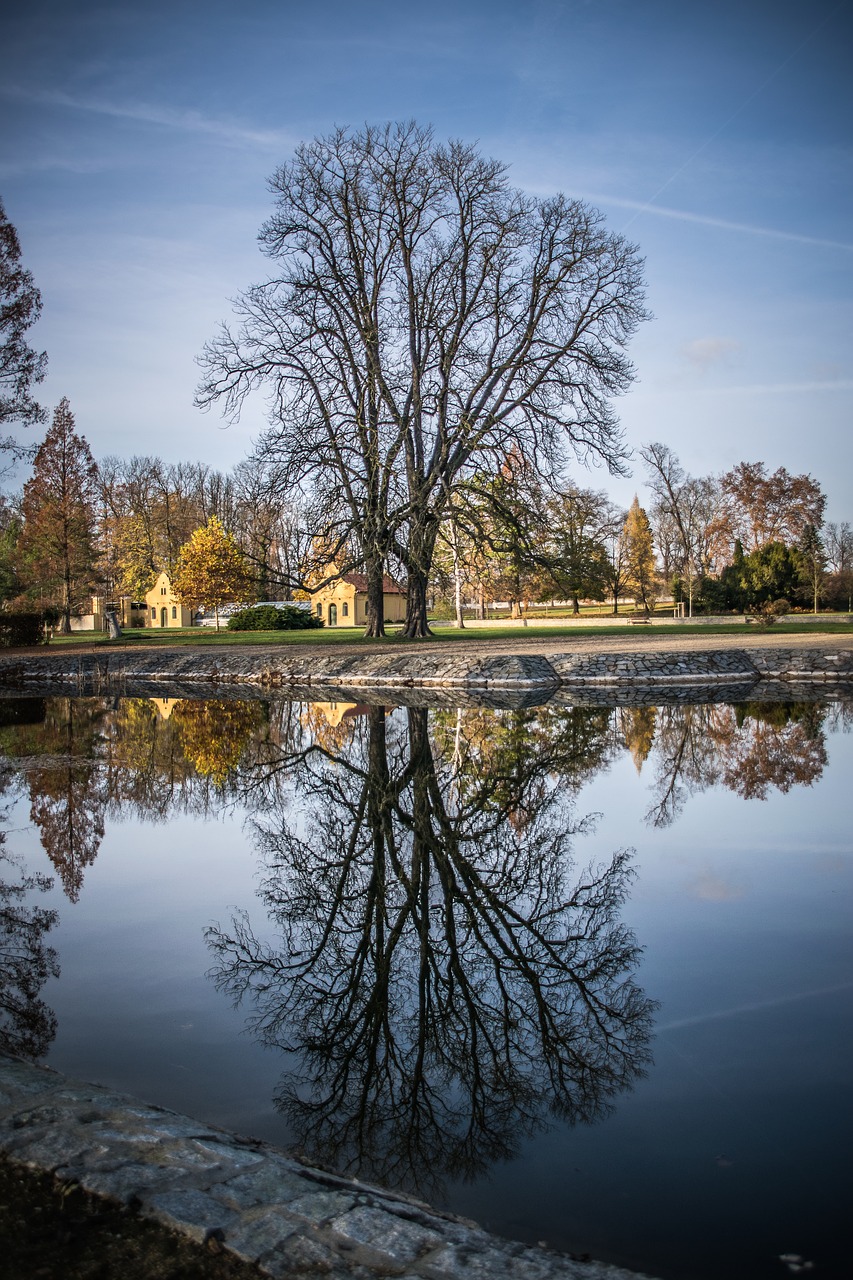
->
0, 698, 852, 1193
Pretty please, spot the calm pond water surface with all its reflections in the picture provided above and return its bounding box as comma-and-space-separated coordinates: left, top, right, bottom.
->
0, 698, 853, 1280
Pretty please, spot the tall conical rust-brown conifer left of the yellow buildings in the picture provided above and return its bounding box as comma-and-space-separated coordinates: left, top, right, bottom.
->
19, 398, 97, 632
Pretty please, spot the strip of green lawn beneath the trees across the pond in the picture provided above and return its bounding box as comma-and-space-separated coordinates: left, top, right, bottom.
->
38, 614, 853, 649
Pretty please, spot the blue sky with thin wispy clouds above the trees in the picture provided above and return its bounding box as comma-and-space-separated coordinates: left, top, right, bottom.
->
0, 0, 853, 520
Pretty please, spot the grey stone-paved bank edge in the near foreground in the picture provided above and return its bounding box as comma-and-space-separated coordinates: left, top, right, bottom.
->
0, 1055, 653, 1280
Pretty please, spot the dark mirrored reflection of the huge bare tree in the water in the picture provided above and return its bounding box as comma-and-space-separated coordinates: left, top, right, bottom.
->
209, 708, 653, 1190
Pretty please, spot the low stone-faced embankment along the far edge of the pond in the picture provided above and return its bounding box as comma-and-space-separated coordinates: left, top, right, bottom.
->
0, 644, 853, 705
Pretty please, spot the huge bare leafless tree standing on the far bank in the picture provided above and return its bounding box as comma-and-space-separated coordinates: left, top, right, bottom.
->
197, 123, 646, 636
